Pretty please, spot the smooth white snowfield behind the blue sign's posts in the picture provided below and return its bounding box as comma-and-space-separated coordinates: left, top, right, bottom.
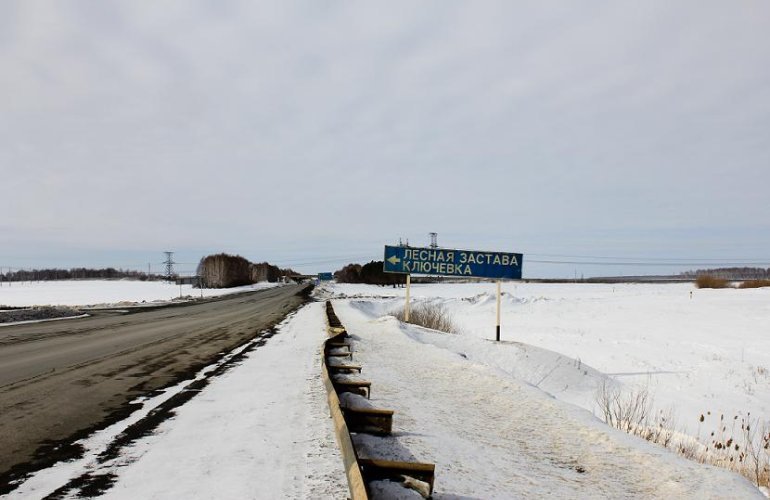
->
326, 283, 770, 438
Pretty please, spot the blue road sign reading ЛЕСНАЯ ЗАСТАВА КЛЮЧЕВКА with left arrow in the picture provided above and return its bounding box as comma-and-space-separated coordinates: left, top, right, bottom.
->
383, 245, 524, 279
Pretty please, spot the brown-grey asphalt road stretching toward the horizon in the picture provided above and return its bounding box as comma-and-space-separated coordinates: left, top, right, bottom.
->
0, 285, 305, 484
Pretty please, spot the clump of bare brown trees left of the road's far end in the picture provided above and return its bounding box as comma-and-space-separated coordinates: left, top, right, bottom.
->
197, 253, 297, 288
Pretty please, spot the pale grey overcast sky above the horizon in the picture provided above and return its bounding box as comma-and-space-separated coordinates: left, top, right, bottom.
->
0, 0, 770, 277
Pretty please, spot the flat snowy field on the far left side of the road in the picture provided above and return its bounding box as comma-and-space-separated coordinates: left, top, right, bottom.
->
0, 280, 278, 308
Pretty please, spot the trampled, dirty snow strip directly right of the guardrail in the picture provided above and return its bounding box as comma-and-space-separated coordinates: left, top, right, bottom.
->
334, 300, 762, 499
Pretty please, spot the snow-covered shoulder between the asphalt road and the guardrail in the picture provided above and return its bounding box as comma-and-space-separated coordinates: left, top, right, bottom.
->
3, 303, 347, 499
